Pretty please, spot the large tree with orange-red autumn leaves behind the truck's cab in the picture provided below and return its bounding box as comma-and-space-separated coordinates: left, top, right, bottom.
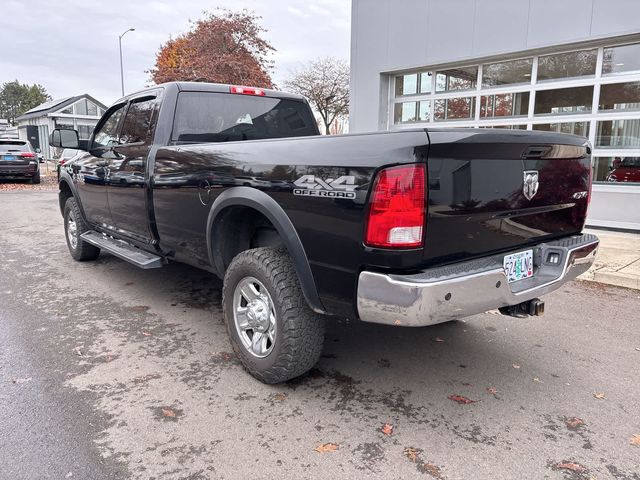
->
149, 9, 275, 88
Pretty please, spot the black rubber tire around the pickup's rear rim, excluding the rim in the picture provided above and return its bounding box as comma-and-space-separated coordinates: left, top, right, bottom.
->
222, 247, 324, 384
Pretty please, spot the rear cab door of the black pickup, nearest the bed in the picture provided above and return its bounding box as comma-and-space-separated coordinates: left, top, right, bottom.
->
107, 94, 160, 243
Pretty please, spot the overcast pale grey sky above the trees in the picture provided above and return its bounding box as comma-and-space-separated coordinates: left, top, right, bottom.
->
0, 0, 351, 105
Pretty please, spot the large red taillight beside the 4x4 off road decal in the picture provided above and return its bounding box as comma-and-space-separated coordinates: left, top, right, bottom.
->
364, 165, 425, 248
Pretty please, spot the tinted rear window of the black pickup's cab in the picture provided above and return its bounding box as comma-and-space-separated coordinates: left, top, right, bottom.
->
171, 92, 318, 145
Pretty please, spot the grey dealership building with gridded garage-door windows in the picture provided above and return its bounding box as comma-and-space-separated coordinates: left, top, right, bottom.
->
349, 0, 640, 230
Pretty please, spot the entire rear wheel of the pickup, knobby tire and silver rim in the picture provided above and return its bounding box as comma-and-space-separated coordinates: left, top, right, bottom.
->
222, 247, 324, 383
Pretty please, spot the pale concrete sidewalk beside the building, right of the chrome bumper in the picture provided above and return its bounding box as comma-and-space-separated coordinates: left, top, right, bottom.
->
578, 230, 640, 290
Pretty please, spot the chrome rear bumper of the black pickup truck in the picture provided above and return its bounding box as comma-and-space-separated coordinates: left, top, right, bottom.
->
357, 234, 599, 327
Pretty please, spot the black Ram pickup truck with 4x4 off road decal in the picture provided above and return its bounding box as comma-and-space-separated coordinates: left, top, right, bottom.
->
50, 83, 598, 383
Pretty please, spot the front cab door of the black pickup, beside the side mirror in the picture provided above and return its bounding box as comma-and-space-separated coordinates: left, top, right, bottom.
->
72, 104, 125, 228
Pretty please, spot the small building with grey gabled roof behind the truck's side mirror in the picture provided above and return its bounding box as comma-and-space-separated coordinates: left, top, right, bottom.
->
16, 93, 107, 158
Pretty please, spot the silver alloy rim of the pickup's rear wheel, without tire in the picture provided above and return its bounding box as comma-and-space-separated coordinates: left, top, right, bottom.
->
233, 277, 277, 358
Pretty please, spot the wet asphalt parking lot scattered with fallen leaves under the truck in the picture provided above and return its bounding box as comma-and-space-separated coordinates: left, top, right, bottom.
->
0, 190, 640, 480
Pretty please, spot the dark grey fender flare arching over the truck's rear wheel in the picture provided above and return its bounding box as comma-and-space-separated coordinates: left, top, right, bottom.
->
207, 187, 325, 313
